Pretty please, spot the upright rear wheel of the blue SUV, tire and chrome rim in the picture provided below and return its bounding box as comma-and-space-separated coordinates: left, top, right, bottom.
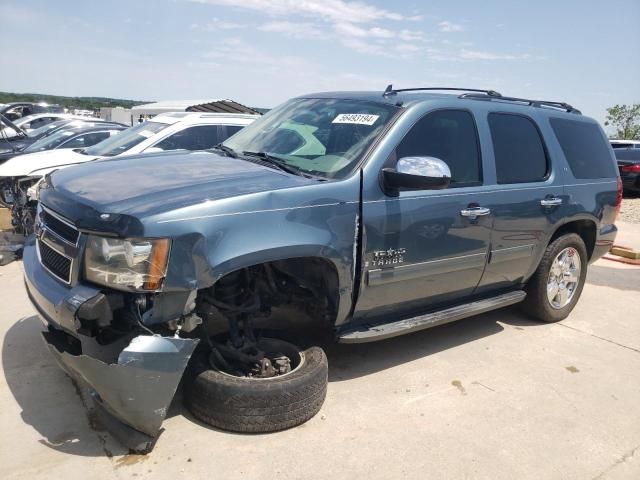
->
522, 233, 588, 322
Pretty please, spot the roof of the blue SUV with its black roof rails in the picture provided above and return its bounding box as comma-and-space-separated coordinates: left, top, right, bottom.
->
299, 85, 586, 118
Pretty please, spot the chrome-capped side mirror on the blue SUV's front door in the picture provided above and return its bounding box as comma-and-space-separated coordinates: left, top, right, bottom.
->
382, 157, 451, 195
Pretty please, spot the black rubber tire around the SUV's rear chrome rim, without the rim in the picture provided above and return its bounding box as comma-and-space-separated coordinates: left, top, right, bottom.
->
521, 233, 589, 323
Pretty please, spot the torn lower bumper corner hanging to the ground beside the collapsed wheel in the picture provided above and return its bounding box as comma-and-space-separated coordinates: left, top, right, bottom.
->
42, 330, 198, 451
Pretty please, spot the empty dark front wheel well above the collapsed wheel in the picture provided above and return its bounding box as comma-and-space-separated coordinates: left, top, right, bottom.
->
196, 257, 339, 331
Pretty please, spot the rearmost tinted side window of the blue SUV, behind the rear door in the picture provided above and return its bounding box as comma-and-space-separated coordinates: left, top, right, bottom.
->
550, 118, 617, 179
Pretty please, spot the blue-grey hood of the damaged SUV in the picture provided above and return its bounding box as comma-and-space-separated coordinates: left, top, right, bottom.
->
48, 151, 315, 218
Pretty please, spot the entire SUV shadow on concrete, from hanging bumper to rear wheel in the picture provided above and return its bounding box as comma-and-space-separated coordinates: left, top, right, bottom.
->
2, 307, 539, 448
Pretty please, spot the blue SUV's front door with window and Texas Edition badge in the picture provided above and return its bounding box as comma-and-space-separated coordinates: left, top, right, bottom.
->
354, 110, 493, 320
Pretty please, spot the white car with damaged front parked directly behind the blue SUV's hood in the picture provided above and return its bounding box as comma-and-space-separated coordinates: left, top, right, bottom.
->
0, 112, 260, 233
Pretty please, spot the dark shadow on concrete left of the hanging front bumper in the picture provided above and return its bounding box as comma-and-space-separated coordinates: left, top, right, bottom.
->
2, 316, 127, 457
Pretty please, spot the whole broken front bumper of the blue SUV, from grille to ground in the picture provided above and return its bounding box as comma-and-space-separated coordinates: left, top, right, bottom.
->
24, 242, 198, 453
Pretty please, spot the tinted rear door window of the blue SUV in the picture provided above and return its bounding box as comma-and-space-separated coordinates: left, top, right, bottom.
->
489, 113, 549, 183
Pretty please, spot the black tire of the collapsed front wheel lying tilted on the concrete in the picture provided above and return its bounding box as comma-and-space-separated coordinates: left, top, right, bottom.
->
184, 339, 329, 433
